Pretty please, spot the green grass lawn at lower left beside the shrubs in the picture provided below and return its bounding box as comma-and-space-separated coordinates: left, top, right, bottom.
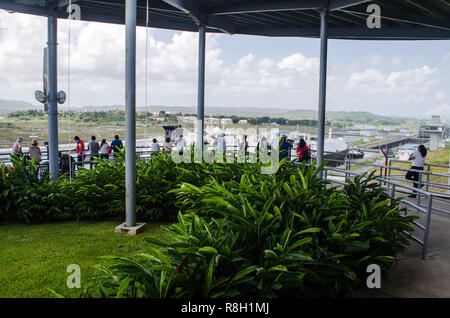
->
0, 221, 169, 298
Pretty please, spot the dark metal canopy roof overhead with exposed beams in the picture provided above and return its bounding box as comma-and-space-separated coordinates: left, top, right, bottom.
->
0, 0, 450, 40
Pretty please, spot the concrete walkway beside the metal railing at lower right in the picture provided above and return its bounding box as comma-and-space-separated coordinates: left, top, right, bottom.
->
355, 199, 450, 298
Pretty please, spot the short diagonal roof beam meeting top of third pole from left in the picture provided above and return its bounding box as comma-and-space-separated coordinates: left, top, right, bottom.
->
162, 0, 235, 34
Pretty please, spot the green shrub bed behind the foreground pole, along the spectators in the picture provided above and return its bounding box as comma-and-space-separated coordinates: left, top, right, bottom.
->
0, 152, 259, 223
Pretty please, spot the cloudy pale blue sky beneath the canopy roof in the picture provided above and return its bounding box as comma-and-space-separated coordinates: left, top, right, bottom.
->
0, 10, 450, 116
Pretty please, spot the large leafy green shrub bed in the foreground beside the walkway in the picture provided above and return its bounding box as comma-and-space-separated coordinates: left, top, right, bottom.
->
78, 161, 415, 298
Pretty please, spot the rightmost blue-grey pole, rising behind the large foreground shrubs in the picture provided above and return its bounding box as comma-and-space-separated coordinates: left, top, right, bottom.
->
316, 10, 328, 170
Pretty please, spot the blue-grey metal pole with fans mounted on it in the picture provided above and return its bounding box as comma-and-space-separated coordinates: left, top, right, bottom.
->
47, 13, 59, 181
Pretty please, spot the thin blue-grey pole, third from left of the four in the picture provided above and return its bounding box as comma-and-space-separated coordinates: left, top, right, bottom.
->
197, 25, 206, 152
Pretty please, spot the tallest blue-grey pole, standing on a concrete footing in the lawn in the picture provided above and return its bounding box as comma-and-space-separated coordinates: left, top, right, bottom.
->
125, 0, 136, 227
